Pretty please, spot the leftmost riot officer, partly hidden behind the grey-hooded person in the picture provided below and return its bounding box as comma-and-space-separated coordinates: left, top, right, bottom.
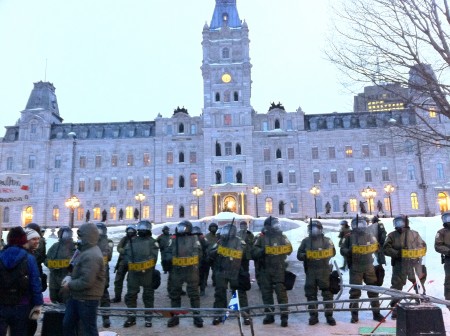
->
44, 226, 75, 303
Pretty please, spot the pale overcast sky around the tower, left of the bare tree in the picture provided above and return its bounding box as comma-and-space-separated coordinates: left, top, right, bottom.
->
0, 0, 353, 136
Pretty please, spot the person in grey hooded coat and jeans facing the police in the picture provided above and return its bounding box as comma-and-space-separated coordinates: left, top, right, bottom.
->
62, 223, 106, 336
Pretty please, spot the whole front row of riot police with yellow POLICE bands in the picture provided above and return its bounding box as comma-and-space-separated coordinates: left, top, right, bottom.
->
38, 212, 450, 328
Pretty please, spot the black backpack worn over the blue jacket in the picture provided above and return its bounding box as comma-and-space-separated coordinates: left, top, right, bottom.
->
0, 255, 30, 305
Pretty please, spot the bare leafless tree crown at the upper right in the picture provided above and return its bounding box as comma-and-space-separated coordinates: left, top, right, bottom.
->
326, 0, 450, 146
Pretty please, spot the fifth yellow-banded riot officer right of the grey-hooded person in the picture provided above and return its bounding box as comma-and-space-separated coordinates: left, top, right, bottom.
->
297, 220, 336, 326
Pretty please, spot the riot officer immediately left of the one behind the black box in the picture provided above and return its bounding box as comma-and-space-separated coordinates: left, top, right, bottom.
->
341, 216, 384, 323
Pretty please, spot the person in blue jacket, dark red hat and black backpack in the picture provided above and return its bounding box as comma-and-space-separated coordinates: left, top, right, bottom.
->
0, 226, 44, 336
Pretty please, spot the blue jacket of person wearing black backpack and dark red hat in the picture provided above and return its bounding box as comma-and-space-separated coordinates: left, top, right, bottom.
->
0, 246, 44, 306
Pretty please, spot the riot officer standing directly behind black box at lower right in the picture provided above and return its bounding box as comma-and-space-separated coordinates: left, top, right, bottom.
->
383, 215, 427, 319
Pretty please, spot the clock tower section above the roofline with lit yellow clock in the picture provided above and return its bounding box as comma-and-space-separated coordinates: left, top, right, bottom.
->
201, 0, 252, 127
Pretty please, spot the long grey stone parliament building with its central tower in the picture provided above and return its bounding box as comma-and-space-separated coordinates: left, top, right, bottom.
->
0, 0, 450, 226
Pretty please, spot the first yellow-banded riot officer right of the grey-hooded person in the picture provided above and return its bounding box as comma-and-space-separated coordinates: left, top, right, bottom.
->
123, 220, 159, 328
